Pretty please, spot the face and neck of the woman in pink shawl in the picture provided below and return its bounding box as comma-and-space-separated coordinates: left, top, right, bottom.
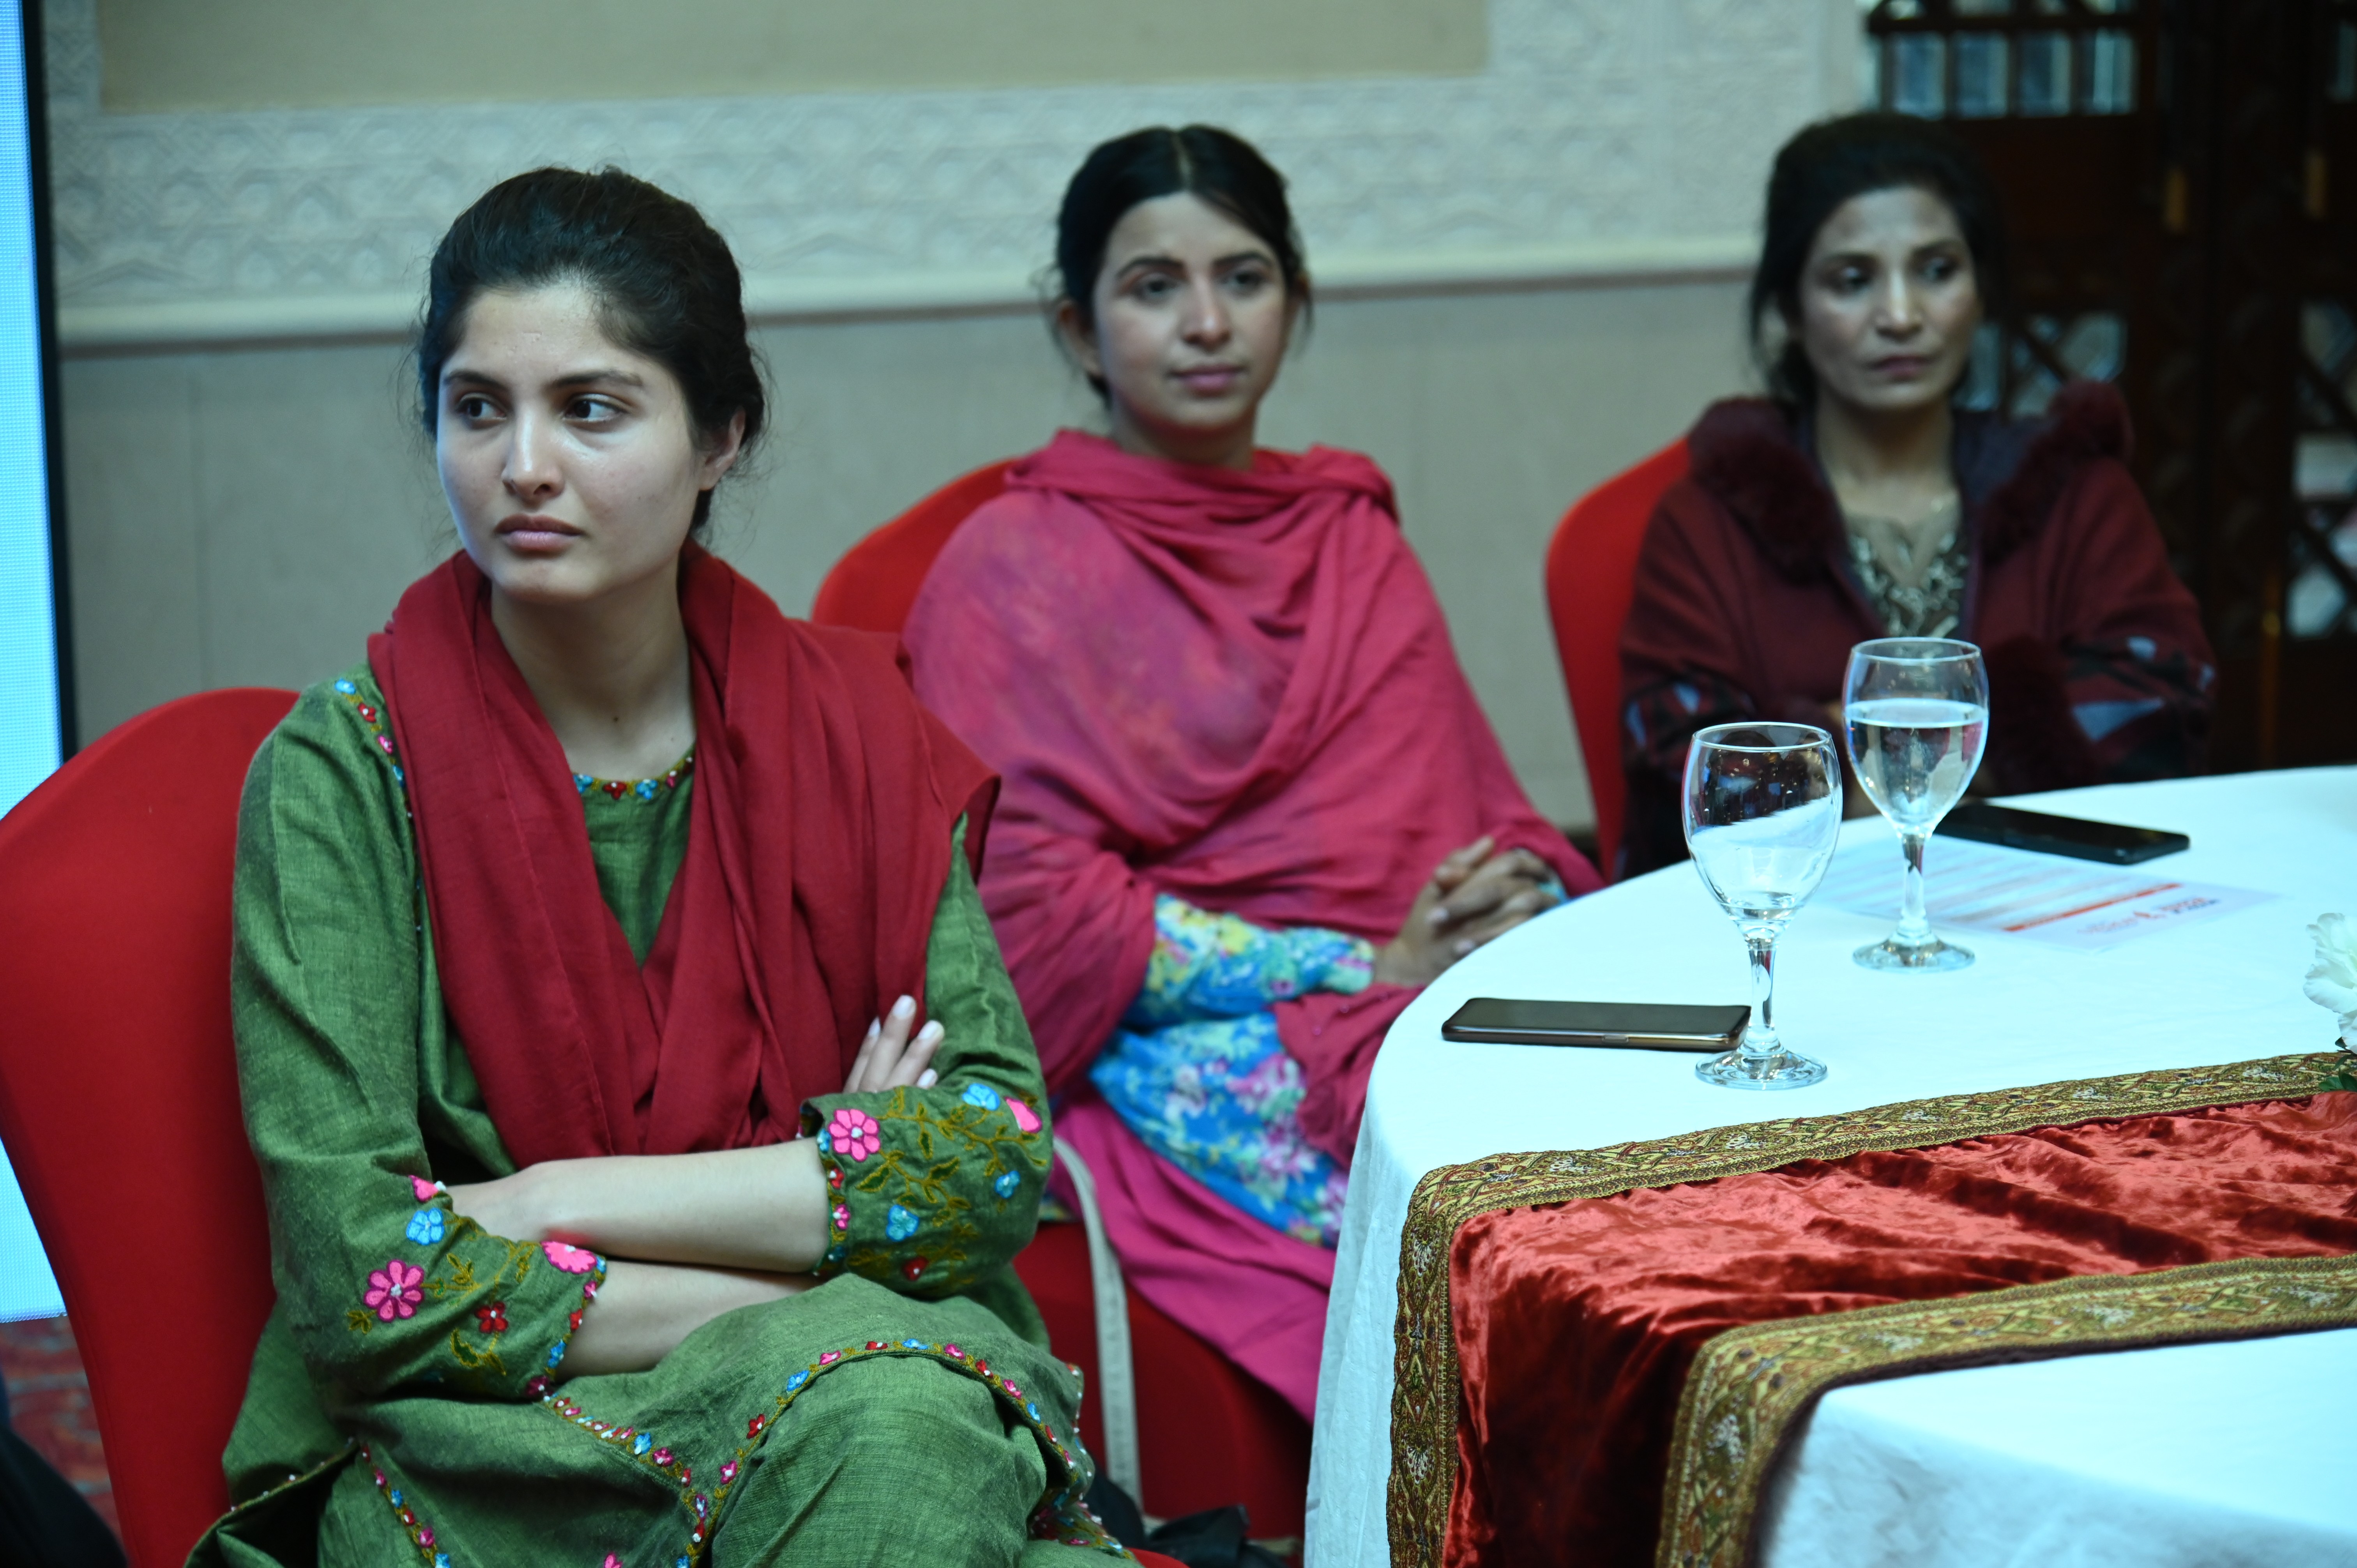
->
1063, 193, 1294, 464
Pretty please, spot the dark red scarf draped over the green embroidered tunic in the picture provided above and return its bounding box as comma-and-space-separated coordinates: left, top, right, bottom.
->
368, 545, 997, 1165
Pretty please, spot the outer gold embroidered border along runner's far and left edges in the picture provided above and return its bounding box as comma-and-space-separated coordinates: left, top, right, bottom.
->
1386, 1052, 2341, 1568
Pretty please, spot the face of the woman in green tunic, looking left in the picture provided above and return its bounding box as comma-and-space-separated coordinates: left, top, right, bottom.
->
434, 283, 742, 604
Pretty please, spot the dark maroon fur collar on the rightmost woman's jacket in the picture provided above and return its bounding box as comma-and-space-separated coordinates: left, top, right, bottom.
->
1685, 382, 2128, 580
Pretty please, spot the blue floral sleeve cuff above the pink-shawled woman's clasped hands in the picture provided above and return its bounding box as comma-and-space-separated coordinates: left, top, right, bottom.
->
1122, 893, 1374, 1030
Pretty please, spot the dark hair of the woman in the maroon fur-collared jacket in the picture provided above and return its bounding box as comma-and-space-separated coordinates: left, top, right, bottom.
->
1749, 111, 2006, 408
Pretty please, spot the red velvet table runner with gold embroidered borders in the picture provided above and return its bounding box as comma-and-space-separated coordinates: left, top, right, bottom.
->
1391, 1054, 2357, 1566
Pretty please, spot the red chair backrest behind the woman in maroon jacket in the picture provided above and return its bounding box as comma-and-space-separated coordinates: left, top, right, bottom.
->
1546, 439, 1685, 877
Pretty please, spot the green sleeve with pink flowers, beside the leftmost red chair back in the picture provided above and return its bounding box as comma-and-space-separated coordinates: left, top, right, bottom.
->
231, 679, 606, 1405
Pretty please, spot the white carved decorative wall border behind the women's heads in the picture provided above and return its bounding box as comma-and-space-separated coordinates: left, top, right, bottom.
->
32, 0, 1857, 351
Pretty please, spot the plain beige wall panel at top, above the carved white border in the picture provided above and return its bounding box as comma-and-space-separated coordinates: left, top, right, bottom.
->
99, 0, 1489, 113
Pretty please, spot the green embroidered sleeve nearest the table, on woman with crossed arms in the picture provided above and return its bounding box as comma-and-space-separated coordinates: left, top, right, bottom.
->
801, 818, 1049, 1297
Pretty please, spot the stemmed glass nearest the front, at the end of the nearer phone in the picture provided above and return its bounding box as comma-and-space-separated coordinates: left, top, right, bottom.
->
1683, 724, 1841, 1089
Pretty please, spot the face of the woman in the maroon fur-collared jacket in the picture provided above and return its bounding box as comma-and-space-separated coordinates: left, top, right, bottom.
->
1799, 186, 1980, 413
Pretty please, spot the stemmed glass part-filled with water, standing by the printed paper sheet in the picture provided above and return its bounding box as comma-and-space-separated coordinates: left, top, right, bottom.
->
1841, 637, 1989, 969
